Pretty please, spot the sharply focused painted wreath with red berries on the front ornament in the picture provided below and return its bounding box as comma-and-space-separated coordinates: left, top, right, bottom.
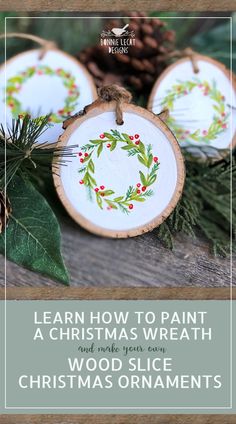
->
78, 130, 160, 214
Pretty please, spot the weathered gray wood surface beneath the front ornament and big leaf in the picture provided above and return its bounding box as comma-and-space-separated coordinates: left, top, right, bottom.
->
0, 216, 232, 287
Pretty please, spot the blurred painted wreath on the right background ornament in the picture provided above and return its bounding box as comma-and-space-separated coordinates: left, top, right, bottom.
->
161, 78, 229, 143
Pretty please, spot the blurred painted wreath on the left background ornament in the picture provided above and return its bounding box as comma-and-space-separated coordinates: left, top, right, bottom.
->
6, 65, 80, 123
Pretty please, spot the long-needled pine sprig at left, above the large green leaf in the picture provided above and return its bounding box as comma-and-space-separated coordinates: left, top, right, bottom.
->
0, 115, 75, 189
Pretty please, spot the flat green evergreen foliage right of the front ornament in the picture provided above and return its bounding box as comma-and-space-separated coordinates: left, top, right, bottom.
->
156, 148, 236, 257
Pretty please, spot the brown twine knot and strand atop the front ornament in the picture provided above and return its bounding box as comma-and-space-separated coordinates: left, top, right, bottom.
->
98, 84, 132, 125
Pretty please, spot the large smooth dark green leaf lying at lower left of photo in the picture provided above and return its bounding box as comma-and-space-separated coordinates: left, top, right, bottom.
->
0, 176, 69, 285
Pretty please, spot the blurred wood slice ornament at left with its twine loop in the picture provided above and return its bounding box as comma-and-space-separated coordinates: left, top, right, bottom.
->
0, 33, 96, 142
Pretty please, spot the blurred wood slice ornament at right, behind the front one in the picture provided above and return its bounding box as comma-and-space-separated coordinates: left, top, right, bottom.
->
148, 53, 236, 149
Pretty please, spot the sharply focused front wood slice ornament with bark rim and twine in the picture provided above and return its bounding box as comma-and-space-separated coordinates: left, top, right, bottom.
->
54, 86, 185, 237
